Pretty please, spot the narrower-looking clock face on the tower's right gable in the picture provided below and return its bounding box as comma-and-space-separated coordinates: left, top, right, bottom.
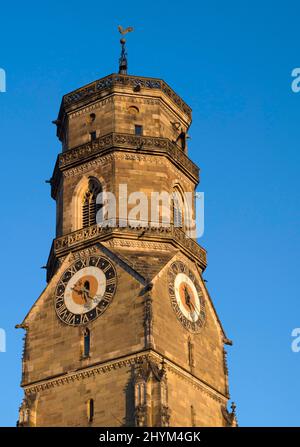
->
168, 261, 205, 332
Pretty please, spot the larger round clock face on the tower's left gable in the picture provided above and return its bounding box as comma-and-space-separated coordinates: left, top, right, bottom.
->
55, 256, 117, 326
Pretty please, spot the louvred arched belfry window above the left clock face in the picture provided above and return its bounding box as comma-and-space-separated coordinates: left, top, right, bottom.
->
82, 179, 102, 228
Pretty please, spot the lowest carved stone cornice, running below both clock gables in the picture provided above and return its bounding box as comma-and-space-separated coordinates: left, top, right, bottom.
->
22, 350, 228, 405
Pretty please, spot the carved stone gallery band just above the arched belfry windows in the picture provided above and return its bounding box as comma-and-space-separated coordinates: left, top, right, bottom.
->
51, 132, 199, 198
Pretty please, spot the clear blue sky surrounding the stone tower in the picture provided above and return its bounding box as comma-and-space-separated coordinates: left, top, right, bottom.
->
0, 0, 300, 426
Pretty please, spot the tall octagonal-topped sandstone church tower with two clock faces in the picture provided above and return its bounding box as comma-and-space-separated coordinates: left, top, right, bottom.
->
17, 34, 236, 427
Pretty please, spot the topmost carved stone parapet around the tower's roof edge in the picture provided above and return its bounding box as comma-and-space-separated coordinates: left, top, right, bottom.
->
58, 74, 192, 123
